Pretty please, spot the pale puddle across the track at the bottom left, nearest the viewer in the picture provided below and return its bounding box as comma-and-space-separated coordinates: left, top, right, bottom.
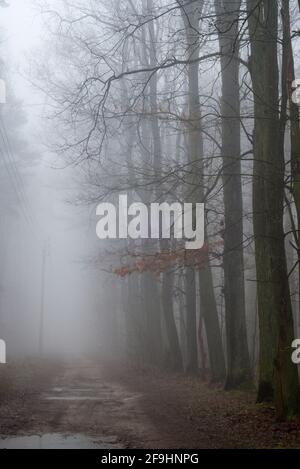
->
0, 433, 121, 449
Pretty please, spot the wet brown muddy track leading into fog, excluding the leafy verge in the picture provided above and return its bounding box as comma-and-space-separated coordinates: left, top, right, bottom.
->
0, 362, 159, 448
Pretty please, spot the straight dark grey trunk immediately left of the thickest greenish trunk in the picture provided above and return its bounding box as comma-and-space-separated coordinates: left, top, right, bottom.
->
215, 0, 251, 389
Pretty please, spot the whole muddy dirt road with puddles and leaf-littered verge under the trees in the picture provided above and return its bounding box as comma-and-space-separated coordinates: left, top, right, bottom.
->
0, 362, 300, 448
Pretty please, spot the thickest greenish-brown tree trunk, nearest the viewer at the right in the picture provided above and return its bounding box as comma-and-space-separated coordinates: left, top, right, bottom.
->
247, 0, 299, 418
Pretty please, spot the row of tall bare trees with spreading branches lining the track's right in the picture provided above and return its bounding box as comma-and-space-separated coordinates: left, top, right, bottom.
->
38, 0, 300, 418
